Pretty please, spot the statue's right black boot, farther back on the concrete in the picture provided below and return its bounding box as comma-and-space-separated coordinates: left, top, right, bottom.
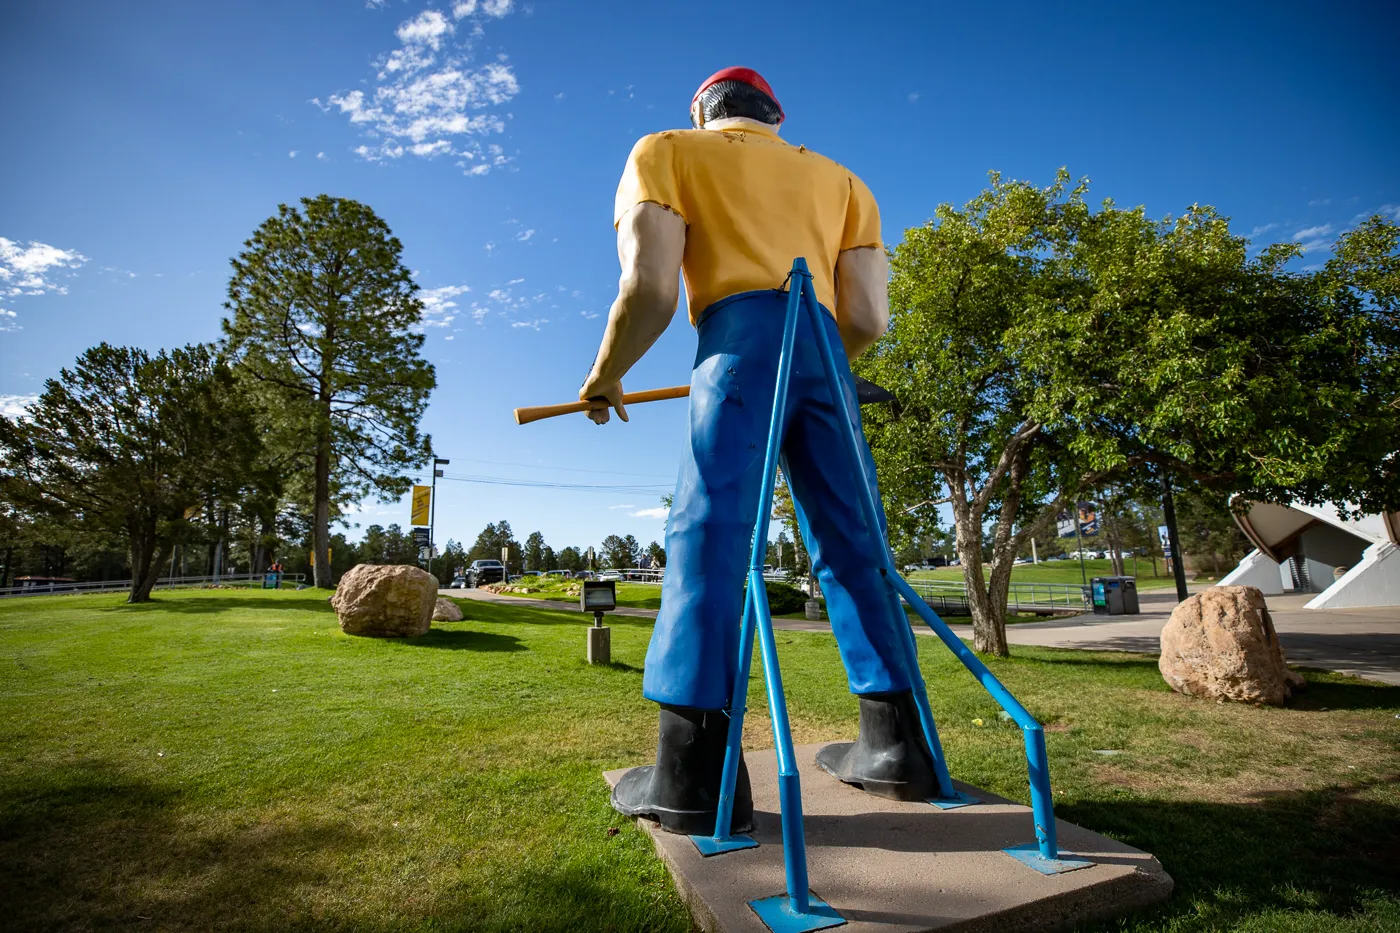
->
816, 691, 938, 800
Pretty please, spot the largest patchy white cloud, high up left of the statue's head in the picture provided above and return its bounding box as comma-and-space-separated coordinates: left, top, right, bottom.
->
322, 0, 519, 175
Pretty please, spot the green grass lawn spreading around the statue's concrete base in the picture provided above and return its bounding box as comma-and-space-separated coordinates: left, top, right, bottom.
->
0, 591, 1400, 933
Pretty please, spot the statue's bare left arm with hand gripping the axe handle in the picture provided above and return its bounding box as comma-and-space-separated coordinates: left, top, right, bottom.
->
578, 202, 688, 424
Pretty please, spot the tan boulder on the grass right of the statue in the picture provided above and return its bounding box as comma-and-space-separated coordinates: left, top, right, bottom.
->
1158, 587, 1303, 706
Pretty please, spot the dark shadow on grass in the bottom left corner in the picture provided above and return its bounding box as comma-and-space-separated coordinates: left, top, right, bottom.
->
0, 762, 372, 932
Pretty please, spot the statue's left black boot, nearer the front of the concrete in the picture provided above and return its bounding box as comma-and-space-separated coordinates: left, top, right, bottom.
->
612, 703, 753, 836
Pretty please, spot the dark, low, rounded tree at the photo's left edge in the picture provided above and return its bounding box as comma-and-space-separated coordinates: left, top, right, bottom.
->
0, 343, 258, 602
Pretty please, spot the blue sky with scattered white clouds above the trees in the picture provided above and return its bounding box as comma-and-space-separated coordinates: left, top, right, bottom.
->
0, 0, 1400, 548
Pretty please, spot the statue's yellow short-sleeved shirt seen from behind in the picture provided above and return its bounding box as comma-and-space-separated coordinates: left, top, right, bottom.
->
613, 126, 881, 324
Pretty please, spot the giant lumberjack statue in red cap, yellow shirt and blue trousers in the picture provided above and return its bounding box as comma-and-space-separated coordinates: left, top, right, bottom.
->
578, 69, 937, 834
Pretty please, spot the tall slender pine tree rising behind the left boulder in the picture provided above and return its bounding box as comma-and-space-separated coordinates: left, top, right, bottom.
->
224, 195, 437, 587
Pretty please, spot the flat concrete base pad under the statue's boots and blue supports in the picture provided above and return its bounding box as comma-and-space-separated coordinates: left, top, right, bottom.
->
603, 745, 1172, 933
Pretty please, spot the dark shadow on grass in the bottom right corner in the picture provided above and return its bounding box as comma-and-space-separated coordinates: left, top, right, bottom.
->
1056, 775, 1400, 932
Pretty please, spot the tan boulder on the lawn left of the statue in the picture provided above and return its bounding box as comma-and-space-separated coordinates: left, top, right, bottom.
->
330, 563, 438, 637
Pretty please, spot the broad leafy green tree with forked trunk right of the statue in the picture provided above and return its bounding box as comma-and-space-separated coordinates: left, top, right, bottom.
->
855, 171, 1400, 654
